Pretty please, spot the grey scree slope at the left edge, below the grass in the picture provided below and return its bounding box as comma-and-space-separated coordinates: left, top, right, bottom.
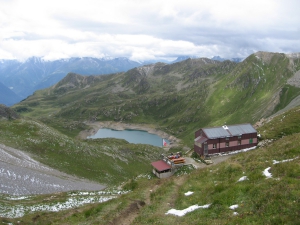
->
0, 144, 105, 195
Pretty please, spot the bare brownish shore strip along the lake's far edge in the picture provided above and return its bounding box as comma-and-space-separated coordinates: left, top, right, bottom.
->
78, 121, 180, 148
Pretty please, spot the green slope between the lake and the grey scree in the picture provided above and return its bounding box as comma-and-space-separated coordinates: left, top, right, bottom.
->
0, 119, 162, 185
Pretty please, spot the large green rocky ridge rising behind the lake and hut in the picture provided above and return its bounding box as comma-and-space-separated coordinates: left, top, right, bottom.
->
13, 52, 300, 143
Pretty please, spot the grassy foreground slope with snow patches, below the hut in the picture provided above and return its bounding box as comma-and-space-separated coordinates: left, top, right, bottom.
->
6, 107, 300, 224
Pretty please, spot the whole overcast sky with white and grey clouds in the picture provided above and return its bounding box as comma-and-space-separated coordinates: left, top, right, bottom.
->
0, 0, 300, 61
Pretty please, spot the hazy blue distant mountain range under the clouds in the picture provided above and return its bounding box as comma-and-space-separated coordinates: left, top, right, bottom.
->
0, 56, 243, 106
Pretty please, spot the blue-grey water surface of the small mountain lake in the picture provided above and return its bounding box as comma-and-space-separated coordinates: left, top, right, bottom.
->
87, 128, 169, 147
